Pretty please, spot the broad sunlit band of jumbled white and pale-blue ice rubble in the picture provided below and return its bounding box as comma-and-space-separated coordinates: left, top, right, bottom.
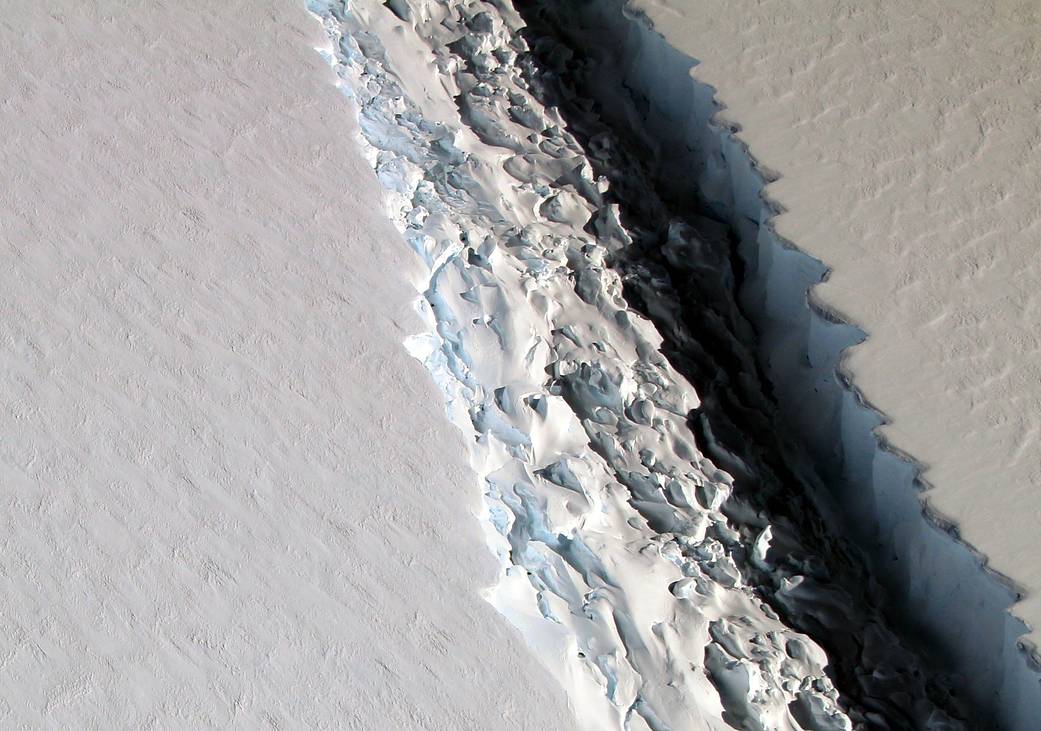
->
310, 0, 974, 730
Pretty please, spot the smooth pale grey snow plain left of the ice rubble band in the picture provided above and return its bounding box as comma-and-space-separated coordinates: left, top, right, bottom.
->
0, 0, 574, 729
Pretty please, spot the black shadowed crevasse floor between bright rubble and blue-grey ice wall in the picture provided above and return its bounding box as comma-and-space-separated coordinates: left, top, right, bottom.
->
514, 0, 978, 729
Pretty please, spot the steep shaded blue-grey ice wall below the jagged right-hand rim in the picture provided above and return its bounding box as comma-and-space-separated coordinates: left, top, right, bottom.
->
528, 0, 1041, 729
